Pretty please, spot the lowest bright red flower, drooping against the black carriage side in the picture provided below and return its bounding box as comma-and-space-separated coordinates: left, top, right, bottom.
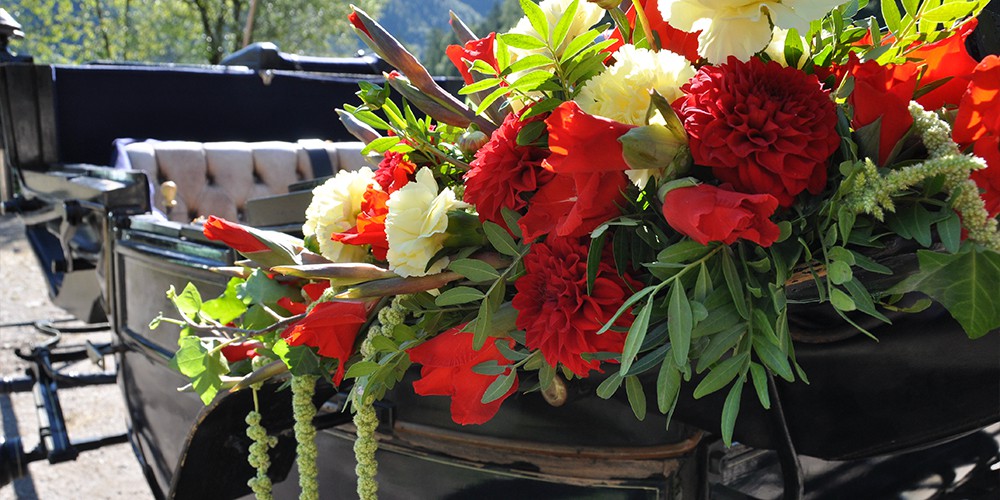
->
409, 328, 517, 425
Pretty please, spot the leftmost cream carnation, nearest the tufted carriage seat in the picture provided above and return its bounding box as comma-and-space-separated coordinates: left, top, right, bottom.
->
302, 167, 378, 262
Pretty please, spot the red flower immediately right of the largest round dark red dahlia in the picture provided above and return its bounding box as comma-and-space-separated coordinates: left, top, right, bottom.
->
837, 52, 920, 165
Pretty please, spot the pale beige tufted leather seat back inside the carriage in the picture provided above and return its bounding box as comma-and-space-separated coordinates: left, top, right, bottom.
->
124, 140, 364, 222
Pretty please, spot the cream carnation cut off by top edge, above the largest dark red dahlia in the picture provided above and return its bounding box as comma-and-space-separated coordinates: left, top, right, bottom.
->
659, 0, 841, 64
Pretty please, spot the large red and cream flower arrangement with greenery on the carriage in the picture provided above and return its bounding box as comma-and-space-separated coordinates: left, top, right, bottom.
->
156, 0, 1000, 498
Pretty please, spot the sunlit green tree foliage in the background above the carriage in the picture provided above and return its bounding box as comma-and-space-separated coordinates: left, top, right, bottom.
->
8, 0, 386, 63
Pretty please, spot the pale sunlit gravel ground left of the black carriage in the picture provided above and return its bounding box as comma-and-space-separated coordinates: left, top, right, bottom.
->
0, 216, 153, 500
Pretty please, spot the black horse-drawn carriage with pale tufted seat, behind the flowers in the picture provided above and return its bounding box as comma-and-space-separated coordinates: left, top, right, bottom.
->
0, 5, 1000, 498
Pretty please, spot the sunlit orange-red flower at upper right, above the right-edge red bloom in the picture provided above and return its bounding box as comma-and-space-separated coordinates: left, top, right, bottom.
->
906, 18, 978, 109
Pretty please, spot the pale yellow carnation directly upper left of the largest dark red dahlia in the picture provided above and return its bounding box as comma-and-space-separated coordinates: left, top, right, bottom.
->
576, 45, 695, 125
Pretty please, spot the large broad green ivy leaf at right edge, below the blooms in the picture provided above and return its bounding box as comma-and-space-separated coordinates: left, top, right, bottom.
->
889, 245, 1000, 339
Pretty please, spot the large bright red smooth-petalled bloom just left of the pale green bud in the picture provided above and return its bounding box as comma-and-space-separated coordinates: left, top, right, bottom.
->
519, 101, 634, 241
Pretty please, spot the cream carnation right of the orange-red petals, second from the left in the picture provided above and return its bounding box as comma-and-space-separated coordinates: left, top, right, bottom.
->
385, 167, 468, 277
